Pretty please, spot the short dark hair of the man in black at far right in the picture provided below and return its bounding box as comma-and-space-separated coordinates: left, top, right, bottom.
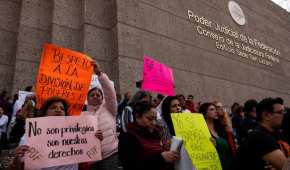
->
257, 97, 284, 121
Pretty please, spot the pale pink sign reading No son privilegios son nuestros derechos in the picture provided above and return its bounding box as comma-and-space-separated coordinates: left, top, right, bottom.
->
24, 116, 101, 169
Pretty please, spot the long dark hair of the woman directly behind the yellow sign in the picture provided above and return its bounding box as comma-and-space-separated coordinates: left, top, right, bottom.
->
161, 96, 179, 136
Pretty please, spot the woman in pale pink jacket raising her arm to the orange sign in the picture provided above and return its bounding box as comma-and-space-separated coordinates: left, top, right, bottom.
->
82, 62, 118, 170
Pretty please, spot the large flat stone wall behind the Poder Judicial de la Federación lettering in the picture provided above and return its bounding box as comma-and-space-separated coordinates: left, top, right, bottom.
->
117, 0, 290, 104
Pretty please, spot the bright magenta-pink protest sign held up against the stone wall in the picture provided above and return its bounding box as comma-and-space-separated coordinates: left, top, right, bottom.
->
142, 56, 174, 96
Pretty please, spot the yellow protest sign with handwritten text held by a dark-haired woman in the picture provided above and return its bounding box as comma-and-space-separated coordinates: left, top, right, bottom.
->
171, 113, 222, 170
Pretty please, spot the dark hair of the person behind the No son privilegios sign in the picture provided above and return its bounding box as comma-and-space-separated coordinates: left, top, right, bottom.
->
39, 97, 68, 117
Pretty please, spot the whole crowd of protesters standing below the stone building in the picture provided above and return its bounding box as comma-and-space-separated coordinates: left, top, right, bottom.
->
0, 60, 290, 170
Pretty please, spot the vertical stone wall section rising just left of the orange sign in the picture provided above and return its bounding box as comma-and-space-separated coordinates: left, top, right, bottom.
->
12, 0, 53, 93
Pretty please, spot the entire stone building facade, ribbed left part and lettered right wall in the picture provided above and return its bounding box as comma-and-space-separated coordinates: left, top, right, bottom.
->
0, 0, 290, 104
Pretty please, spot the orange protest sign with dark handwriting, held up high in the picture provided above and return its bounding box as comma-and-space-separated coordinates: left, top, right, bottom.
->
36, 44, 93, 115
